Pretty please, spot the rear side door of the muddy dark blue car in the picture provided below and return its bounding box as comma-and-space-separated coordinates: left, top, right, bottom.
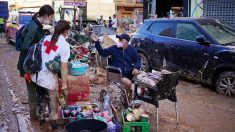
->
146, 21, 174, 70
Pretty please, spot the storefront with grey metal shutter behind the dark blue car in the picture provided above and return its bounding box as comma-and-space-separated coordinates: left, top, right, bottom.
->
144, 0, 235, 29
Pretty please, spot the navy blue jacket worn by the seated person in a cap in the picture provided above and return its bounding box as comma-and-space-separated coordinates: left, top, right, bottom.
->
95, 41, 141, 79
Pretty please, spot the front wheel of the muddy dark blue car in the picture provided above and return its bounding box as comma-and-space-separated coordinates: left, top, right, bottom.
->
216, 71, 235, 96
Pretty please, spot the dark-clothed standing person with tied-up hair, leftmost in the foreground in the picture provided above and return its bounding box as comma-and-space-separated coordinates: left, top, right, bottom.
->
17, 5, 54, 120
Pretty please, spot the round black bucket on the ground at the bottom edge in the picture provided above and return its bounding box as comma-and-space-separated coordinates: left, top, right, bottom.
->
65, 119, 108, 132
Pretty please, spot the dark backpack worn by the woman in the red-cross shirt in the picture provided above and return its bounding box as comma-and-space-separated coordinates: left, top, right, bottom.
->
23, 38, 44, 74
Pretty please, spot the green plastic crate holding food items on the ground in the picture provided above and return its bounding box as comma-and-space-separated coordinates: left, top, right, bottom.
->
122, 112, 150, 132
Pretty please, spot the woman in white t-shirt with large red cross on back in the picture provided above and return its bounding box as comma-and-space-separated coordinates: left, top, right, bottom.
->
32, 20, 70, 130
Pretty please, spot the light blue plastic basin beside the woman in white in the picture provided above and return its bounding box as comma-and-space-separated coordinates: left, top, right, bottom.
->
69, 61, 88, 76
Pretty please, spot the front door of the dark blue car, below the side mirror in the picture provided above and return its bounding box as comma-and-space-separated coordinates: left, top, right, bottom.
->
170, 22, 212, 79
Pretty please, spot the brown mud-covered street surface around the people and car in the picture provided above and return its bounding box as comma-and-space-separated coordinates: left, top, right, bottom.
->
0, 38, 235, 132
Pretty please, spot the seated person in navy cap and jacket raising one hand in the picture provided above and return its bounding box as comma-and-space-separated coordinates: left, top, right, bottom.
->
91, 34, 141, 96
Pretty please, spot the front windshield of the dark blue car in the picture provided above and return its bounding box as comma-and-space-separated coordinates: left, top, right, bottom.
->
202, 23, 235, 45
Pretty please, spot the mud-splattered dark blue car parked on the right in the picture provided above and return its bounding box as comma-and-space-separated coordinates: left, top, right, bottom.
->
130, 18, 235, 96
